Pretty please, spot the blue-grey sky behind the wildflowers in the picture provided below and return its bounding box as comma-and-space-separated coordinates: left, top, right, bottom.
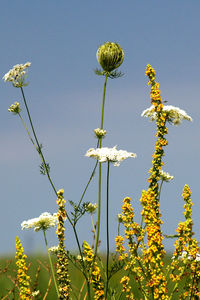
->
0, 0, 200, 254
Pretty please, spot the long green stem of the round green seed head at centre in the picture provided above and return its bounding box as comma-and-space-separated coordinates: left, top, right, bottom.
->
94, 74, 108, 259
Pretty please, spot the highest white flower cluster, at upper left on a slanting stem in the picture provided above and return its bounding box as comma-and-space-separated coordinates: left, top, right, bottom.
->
3, 62, 31, 88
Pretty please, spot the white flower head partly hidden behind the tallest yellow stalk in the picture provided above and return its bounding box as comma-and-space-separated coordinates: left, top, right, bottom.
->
141, 105, 192, 125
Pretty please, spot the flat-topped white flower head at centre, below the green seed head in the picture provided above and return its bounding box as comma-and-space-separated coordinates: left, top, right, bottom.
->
85, 146, 137, 167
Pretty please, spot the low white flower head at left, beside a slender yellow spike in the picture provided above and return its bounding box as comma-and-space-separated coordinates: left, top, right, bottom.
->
21, 212, 58, 231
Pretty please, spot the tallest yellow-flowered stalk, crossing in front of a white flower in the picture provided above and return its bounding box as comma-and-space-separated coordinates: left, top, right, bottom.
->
140, 65, 168, 299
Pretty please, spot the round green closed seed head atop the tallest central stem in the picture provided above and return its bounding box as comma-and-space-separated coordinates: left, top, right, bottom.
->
97, 42, 124, 73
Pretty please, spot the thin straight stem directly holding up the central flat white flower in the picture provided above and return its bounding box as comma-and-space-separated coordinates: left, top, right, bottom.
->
105, 161, 110, 299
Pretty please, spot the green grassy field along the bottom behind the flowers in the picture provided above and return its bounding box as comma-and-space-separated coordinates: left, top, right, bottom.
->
0, 255, 178, 300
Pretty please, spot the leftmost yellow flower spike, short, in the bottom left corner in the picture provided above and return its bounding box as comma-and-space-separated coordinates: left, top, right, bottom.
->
15, 237, 32, 300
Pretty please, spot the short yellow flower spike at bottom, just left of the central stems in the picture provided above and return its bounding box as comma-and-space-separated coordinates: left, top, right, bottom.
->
83, 241, 105, 300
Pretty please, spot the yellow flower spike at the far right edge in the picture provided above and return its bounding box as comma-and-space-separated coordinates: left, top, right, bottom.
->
170, 185, 200, 299
